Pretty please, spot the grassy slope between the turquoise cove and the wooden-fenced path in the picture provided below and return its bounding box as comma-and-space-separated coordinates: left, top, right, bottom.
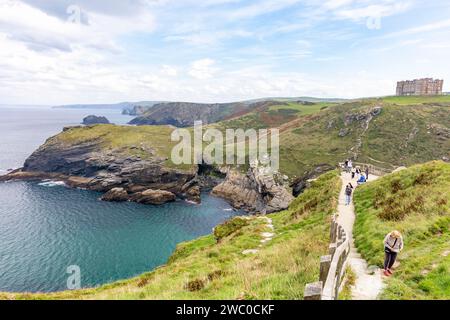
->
0, 172, 341, 299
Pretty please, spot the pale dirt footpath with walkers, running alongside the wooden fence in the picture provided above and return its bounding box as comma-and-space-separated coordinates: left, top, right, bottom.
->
337, 172, 384, 300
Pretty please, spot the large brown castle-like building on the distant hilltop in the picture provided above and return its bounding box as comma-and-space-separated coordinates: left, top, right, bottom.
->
397, 78, 444, 96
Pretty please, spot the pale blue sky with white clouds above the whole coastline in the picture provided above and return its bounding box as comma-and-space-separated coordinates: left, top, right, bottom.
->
0, 0, 450, 105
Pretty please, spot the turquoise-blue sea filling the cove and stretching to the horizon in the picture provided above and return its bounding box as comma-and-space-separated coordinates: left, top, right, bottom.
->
0, 105, 243, 292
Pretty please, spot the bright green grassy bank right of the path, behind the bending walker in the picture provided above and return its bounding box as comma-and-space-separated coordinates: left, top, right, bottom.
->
354, 161, 450, 299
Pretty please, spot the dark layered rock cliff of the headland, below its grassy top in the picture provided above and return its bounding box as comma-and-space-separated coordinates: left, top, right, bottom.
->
10, 129, 200, 204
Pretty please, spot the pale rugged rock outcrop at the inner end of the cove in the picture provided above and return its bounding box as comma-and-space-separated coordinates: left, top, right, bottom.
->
212, 166, 294, 214
